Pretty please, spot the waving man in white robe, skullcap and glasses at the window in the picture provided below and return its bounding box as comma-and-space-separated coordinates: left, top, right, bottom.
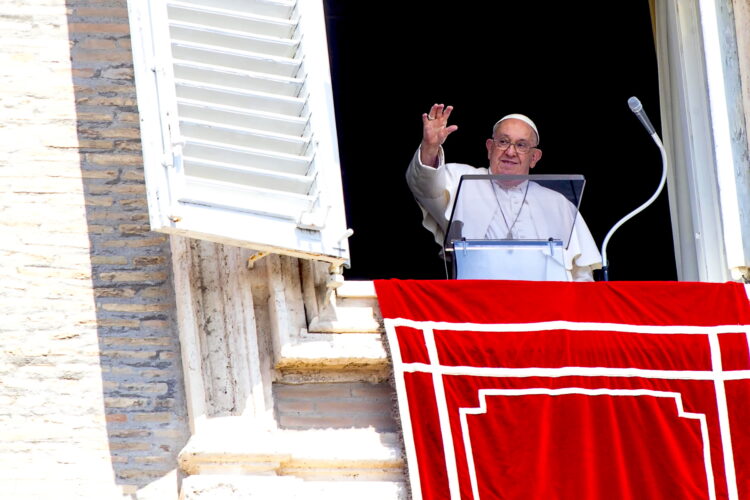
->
406, 104, 601, 281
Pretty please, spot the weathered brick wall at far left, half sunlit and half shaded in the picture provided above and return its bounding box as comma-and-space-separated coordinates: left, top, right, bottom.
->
0, 0, 188, 498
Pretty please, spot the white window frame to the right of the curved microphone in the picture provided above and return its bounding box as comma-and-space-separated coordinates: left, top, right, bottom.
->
654, 0, 750, 282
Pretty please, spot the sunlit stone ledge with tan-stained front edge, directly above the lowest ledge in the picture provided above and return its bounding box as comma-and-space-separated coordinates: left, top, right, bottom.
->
179, 417, 404, 481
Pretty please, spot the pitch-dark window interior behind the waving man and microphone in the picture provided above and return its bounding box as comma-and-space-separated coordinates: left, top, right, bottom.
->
325, 0, 676, 280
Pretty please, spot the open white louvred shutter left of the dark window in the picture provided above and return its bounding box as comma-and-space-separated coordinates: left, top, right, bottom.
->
128, 0, 349, 263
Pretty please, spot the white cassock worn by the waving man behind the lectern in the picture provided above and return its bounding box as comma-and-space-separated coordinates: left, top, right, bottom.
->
406, 148, 602, 281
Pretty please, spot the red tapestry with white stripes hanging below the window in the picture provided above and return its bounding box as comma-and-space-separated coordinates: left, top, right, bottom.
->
375, 280, 750, 500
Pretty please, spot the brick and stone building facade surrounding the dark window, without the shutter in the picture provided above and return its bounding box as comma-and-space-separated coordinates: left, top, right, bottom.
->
0, 0, 750, 499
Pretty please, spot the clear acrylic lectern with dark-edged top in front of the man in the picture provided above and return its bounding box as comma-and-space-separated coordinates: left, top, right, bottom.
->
443, 175, 586, 281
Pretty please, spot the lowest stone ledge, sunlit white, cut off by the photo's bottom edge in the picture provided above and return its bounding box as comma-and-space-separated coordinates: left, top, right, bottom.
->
180, 475, 407, 500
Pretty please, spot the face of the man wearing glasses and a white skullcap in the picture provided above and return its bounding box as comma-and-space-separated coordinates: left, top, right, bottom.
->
487, 118, 542, 175
